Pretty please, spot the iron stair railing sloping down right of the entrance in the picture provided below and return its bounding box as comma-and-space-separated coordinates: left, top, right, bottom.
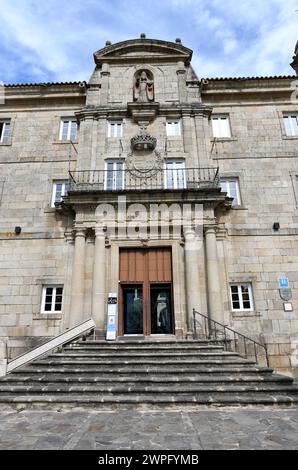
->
193, 309, 269, 367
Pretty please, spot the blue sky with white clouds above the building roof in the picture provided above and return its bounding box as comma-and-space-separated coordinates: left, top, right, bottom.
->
0, 0, 298, 83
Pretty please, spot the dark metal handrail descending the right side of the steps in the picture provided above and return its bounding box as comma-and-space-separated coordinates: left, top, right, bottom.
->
193, 309, 269, 367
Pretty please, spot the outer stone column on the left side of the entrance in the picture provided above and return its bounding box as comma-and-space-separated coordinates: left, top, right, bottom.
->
70, 228, 86, 327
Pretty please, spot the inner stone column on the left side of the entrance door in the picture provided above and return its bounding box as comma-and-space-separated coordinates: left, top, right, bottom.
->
92, 227, 106, 332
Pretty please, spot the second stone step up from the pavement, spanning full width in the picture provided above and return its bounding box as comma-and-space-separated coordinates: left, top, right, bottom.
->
0, 383, 298, 399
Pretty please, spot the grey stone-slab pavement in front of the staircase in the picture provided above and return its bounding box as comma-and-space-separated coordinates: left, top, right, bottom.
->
0, 408, 298, 450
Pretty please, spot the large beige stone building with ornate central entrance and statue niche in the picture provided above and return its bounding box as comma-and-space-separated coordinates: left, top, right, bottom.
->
0, 35, 298, 373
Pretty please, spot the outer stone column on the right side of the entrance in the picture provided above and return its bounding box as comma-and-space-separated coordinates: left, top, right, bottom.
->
205, 225, 224, 324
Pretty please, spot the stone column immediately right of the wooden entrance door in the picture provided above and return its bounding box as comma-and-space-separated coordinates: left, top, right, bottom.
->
184, 228, 202, 337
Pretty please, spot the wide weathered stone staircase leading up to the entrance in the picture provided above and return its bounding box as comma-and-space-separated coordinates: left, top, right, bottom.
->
0, 340, 298, 408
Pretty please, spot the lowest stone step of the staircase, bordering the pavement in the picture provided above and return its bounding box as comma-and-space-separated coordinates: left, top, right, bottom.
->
0, 392, 298, 409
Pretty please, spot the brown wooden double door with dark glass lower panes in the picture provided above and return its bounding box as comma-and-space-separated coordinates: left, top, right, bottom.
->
119, 248, 174, 335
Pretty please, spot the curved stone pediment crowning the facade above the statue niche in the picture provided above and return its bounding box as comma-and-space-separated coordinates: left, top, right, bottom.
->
94, 39, 192, 65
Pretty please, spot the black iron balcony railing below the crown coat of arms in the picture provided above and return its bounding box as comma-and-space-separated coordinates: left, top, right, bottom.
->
68, 167, 219, 192
